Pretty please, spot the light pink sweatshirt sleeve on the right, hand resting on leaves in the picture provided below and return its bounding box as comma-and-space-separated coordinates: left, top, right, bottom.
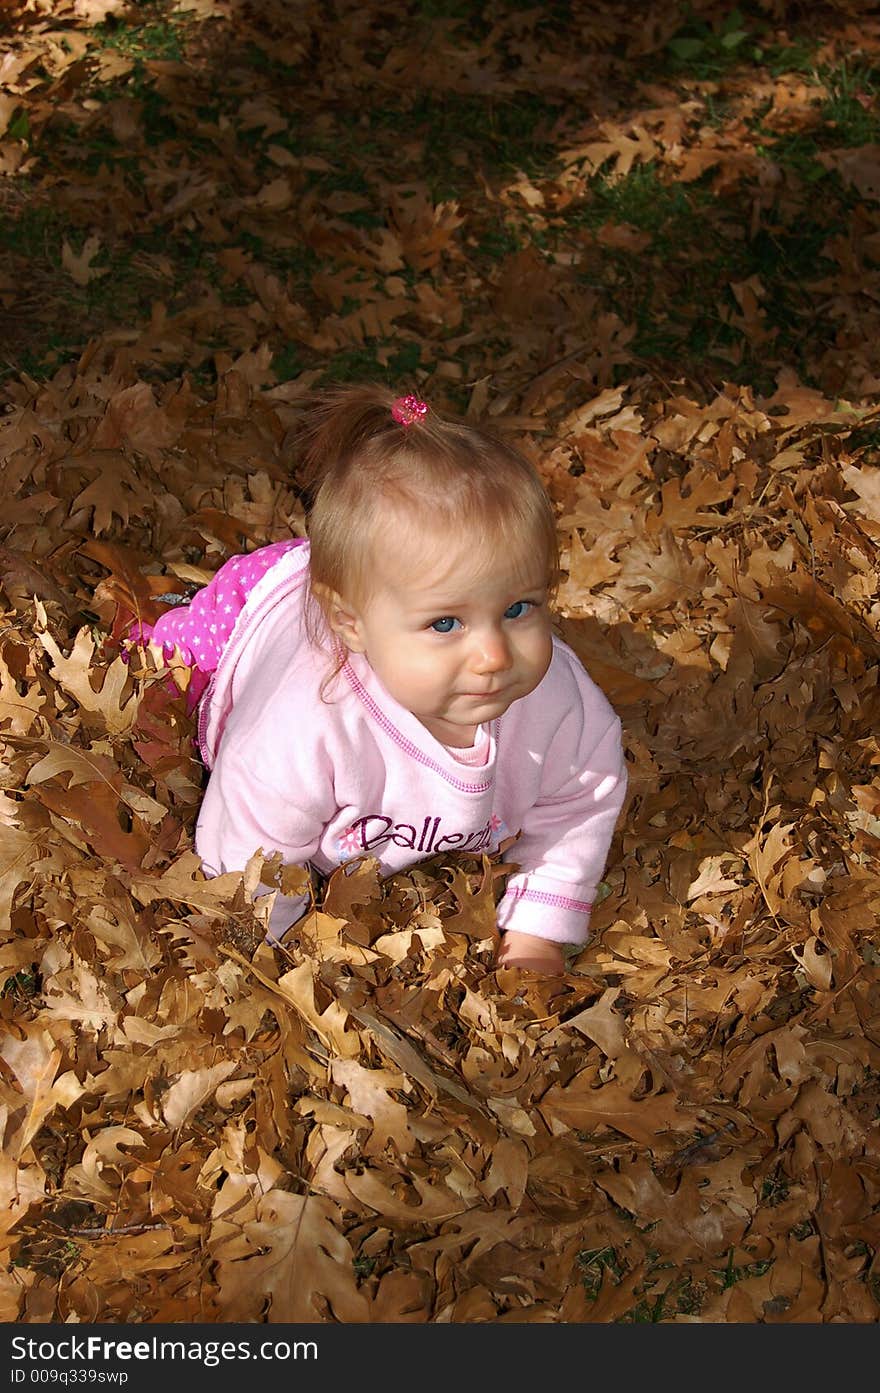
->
497, 673, 627, 944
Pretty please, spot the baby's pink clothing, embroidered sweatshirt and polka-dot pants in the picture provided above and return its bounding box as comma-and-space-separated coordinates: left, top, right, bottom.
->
175, 542, 627, 944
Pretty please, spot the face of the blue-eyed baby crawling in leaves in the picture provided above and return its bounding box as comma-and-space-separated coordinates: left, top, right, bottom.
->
335, 523, 551, 747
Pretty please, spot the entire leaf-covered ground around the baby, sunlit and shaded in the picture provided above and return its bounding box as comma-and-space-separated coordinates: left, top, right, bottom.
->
0, 0, 880, 1323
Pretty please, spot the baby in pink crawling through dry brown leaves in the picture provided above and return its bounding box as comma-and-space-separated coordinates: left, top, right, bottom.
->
144, 386, 627, 975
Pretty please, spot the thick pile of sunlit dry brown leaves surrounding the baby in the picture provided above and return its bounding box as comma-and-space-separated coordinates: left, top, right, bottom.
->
0, 352, 880, 1322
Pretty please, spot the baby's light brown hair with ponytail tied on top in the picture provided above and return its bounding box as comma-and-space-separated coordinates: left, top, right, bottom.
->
294, 384, 560, 685
